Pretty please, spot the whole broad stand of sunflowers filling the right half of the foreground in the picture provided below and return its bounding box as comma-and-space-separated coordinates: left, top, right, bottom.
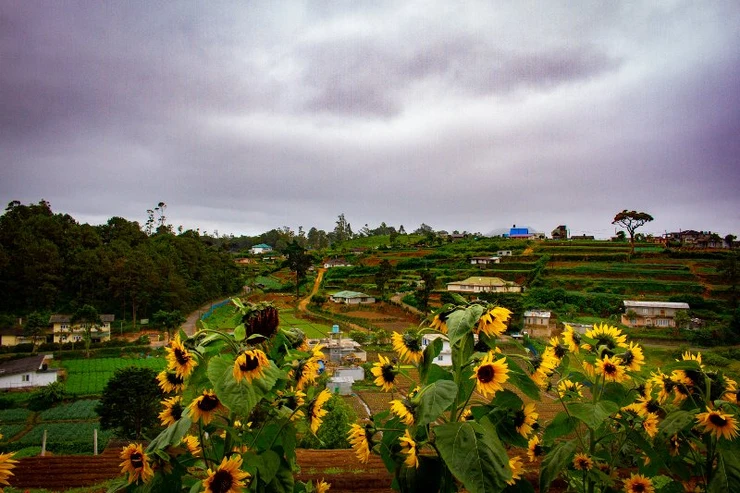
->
349, 303, 740, 493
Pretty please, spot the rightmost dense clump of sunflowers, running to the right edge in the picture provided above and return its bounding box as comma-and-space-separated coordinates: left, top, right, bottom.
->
528, 324, 740, 493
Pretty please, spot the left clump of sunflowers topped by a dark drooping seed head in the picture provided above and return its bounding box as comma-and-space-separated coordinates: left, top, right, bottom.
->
112, 299, 331, 493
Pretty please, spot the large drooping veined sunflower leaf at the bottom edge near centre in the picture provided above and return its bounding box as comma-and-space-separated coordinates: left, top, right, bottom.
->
434, 418, 512, 493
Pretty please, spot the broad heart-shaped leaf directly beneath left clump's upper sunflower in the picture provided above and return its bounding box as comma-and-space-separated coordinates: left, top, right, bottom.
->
208, 354, 280, 416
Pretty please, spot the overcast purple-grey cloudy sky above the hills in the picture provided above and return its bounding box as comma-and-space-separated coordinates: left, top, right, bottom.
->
0, 0, 740, 237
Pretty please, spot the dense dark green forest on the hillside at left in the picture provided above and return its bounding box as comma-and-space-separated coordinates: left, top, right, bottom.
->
0, 201, 240, 320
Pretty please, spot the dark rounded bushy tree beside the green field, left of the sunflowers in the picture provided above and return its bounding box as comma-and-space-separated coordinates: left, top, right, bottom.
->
95, 366, 162, 440
